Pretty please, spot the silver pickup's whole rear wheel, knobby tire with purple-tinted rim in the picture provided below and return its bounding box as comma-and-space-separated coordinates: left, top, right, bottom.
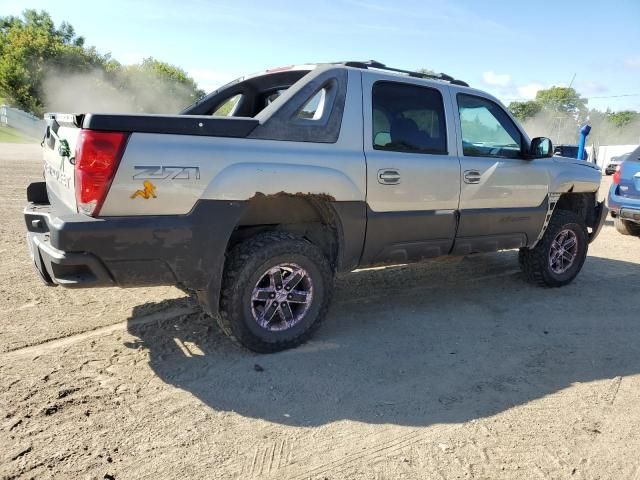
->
218, 232, 333, 353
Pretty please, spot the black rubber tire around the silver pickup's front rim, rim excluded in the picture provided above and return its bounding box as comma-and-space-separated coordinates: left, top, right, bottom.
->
519, 210, 589, 287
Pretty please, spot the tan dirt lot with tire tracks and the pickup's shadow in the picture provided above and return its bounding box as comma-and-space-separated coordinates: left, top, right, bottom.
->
0, 144, 640, 480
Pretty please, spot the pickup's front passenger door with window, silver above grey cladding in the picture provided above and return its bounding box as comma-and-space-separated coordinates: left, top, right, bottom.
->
454, 92, 552, 254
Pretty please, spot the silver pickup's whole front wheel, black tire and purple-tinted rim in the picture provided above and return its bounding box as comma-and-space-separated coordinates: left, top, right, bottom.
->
519, 210, 589, 287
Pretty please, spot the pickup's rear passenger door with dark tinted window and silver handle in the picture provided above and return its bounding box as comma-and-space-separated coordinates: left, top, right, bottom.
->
361, 77, 460, 265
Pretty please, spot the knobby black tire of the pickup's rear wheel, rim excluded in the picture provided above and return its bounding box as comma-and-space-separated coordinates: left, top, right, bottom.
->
217, 232, 333, 353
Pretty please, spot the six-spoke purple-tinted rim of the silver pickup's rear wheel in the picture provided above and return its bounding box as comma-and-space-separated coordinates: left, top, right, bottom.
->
251, 263, 313, 331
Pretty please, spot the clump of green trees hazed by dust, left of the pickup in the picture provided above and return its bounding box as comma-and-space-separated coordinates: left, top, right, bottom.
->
0, 10, 204, 115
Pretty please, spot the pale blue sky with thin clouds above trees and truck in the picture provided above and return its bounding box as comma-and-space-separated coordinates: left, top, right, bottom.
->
0, 0, 640, 111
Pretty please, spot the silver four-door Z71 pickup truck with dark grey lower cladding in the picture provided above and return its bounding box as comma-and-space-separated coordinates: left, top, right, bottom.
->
24, 61, 606, 352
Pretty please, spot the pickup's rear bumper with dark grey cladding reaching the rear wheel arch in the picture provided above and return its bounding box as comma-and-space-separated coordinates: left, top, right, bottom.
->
24, 187, 245, 313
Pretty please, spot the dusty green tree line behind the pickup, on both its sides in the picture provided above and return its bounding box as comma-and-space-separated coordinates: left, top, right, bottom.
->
0, 10, 640, 144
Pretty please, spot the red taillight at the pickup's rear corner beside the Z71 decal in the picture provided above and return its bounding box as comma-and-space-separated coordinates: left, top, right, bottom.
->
75, 130, 129, 217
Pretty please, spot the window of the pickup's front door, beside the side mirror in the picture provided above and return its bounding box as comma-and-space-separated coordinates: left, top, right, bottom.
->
458, 94, 522, 158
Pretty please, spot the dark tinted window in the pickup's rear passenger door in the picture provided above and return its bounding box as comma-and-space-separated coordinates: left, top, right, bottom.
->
372, 82, 447, 155
